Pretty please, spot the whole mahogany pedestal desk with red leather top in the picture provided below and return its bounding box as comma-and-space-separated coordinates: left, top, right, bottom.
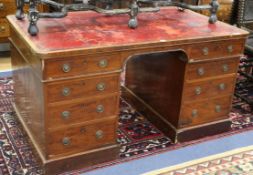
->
8, 7, 247, 174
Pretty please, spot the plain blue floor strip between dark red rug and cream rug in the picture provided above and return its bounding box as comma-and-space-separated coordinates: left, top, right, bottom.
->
81, 131, 253, 175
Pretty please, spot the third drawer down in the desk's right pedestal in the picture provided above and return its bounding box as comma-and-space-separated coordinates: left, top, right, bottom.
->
183, 74, 236, 103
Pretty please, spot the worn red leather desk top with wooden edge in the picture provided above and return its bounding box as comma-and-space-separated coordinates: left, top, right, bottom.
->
8, 7, 247, 53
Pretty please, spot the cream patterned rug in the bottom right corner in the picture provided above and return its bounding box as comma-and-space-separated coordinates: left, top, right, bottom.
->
143, 146, 253, 175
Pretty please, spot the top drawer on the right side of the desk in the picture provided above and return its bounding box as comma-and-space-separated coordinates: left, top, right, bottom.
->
187, 39, 245, 62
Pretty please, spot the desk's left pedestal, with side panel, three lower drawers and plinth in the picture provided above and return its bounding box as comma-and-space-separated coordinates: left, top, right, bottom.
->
11, 35, 119, 175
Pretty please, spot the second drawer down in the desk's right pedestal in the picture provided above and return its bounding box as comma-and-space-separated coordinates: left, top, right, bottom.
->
186, 57, 239, 80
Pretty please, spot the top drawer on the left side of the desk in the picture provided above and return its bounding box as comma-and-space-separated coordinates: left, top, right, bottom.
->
44, 54, 121, 79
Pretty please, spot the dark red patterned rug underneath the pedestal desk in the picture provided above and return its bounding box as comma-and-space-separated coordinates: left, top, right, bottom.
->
0, 78, 253, 175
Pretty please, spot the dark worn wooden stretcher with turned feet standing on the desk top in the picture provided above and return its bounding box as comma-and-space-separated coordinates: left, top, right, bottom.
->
16, 0, 219, 36
